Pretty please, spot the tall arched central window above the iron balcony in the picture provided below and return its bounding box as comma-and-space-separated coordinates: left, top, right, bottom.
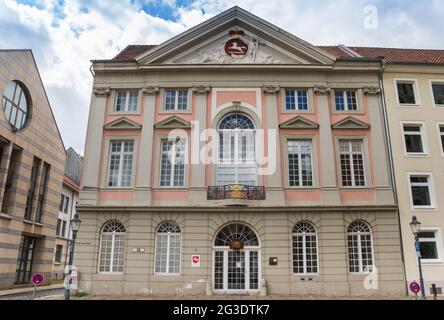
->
217, 113, 257, 185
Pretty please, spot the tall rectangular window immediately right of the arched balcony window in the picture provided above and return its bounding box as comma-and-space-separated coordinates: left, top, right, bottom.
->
287, 140, 313, 187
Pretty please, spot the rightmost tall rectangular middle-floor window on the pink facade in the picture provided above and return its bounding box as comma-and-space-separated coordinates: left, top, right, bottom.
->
339, 140, 365, 187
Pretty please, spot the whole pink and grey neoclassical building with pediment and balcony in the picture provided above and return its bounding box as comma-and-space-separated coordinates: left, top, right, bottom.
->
74, 7, 405, 296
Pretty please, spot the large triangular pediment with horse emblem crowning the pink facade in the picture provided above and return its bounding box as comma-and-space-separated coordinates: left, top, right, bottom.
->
136, 7, 335, 65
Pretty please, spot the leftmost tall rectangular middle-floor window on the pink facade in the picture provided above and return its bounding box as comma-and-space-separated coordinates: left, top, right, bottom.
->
107, 140, 134, 187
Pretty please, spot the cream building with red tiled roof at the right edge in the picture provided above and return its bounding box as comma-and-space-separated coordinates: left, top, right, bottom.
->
325, 47, 444, 295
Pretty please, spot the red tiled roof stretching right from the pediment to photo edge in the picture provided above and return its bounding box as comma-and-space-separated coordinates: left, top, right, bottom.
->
319, 46, 444, 64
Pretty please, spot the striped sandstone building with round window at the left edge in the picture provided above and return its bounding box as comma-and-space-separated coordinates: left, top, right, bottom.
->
0, 50, 65, 288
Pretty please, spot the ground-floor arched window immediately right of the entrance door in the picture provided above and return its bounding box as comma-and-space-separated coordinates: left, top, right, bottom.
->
293, 221, 318, 274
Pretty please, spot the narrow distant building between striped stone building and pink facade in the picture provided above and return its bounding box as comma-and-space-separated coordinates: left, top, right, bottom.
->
52, 148, 83, 279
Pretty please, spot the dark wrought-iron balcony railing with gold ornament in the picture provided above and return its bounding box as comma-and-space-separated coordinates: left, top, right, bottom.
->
207, 184, 265, 200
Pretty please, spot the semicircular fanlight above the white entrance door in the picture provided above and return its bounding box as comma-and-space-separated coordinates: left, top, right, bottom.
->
214, 223, 259, 247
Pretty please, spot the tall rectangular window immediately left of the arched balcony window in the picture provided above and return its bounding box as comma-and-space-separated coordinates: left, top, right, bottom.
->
160, 139, 186, 187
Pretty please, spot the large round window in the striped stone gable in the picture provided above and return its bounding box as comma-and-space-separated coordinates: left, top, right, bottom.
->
2, 81, 31, 131
